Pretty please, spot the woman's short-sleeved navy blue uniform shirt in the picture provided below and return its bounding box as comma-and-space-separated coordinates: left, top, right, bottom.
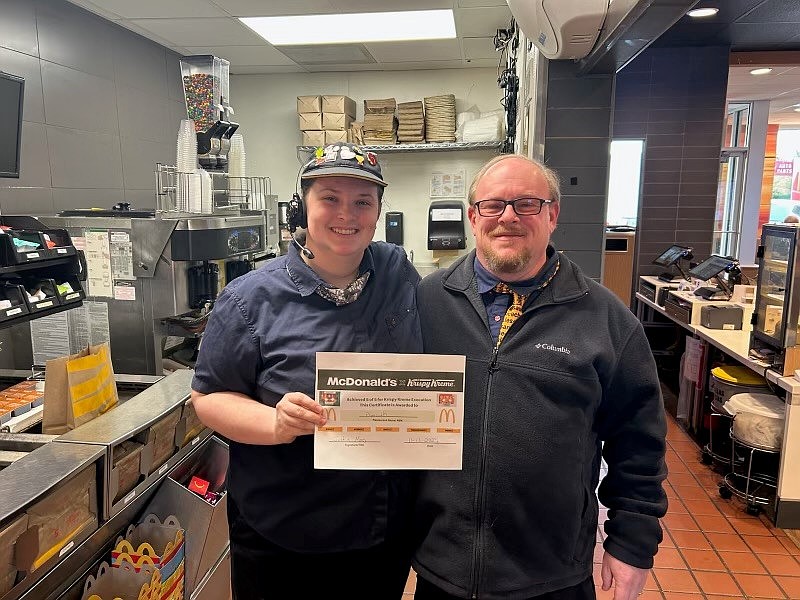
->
192, 242, 422, 552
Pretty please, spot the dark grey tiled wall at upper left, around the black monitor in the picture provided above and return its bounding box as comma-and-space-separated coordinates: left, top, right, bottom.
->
0, 0, 186, 214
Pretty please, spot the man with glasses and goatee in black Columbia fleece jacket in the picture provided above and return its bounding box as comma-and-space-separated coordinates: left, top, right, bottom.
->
413, 155, 667, 600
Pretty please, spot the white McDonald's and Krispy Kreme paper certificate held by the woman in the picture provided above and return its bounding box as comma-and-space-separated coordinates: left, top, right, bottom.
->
314, 352, 466, 470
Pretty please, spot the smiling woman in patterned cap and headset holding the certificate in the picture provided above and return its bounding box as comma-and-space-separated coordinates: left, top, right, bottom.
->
192, 144, 422, 600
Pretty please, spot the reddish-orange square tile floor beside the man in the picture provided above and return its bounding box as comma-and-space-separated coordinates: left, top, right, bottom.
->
403, 417, 800, 600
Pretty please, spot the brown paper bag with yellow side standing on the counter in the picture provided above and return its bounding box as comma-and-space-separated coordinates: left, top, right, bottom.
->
42, 343, 118, 435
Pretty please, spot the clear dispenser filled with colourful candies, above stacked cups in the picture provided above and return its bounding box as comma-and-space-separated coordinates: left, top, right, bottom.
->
181, 54, 239, 172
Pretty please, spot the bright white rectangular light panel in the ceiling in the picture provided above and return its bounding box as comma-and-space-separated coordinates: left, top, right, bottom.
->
241, 10, 456, 46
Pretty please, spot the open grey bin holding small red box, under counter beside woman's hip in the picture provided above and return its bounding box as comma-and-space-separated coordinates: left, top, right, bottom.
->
145, 437, 229, 598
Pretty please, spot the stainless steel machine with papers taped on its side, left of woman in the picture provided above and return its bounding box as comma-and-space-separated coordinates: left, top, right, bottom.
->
21, 210, 267, 375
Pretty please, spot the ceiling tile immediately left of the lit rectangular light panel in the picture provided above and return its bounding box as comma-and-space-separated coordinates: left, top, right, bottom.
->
130, 18, 264, 47
